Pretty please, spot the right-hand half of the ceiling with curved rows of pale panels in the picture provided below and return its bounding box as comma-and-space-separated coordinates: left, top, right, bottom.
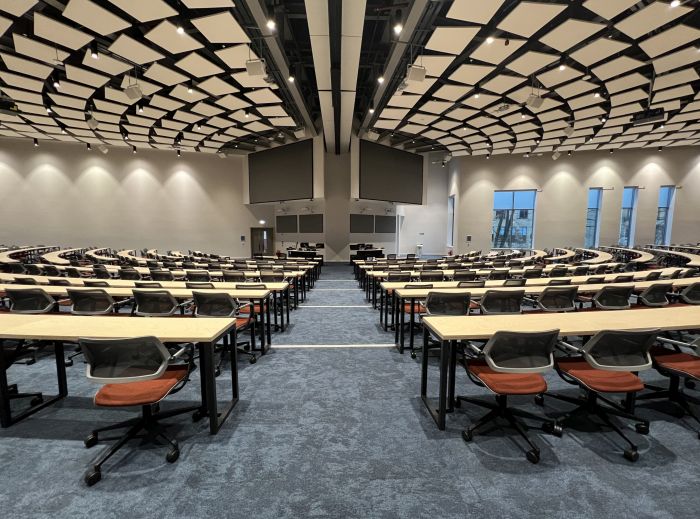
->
360, 0, 700, 155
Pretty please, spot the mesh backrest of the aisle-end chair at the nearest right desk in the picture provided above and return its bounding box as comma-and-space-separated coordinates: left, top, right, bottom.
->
483, 330, 559, 373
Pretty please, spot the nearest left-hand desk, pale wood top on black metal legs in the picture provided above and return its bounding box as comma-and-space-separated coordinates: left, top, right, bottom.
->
0, 313, 238, 434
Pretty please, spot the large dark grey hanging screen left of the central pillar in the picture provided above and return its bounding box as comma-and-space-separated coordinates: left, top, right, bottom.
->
248, 139, 314, 204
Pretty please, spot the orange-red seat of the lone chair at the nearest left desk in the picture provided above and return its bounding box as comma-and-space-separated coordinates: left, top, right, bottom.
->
95, 365, 187, 407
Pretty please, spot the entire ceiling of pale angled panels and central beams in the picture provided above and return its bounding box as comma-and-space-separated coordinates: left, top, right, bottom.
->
0, 0, 700, 156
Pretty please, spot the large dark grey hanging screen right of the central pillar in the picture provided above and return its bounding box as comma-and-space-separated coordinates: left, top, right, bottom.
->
360, 140, 423, 204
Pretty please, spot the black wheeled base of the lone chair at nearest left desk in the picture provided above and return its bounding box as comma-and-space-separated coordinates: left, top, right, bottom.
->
83, 404, 200, 487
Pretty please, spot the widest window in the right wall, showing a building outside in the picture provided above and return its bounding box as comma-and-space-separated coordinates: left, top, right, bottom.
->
491, 189, 535, 249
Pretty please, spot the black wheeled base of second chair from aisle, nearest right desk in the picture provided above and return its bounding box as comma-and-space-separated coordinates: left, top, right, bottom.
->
535, 388, 649, 461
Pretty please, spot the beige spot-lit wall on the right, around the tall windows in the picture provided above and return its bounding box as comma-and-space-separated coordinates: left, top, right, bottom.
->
448, 147, 700, 252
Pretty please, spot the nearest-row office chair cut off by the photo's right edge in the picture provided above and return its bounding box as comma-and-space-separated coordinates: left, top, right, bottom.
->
637, 337, 700, 439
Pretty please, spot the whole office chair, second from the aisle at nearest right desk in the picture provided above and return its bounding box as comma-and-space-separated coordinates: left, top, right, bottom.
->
535, 330, 658, 461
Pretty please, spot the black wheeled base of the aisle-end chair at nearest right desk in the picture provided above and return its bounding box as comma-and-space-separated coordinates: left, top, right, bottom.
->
455, 395, 562, 463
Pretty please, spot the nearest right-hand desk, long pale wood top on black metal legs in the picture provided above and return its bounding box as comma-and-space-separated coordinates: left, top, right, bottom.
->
420, 306, 700, 430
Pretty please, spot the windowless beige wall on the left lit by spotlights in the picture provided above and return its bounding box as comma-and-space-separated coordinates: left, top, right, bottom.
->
0, 139, 272, 256
